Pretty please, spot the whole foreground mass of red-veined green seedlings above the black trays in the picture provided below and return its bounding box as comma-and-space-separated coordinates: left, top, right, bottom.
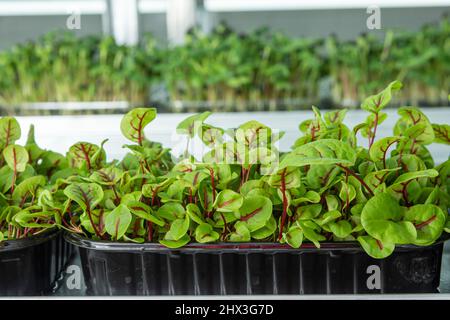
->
0, 81, 450, 258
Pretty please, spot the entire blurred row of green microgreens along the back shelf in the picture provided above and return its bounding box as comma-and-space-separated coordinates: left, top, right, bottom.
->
0, 18, 450, 111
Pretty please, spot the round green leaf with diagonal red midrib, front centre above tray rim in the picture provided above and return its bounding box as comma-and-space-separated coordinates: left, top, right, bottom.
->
239, 196, 272, 232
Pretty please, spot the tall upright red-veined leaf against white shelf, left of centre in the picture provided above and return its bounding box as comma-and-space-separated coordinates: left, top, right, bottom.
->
120, 108, 156, 145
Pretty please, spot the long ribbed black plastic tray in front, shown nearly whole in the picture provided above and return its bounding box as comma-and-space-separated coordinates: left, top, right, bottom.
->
65, 234, 448, 296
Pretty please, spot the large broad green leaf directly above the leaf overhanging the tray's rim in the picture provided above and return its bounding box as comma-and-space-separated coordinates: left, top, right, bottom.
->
361, 193, 417, 244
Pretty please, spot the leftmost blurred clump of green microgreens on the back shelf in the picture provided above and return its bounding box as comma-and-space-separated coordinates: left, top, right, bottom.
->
0, 32, 158, 110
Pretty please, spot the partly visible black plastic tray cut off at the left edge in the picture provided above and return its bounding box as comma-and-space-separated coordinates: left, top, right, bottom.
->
0, 230, 74, 296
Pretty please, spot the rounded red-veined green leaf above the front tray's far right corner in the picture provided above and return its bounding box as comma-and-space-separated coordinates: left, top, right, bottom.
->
404, 204, 447, 246
